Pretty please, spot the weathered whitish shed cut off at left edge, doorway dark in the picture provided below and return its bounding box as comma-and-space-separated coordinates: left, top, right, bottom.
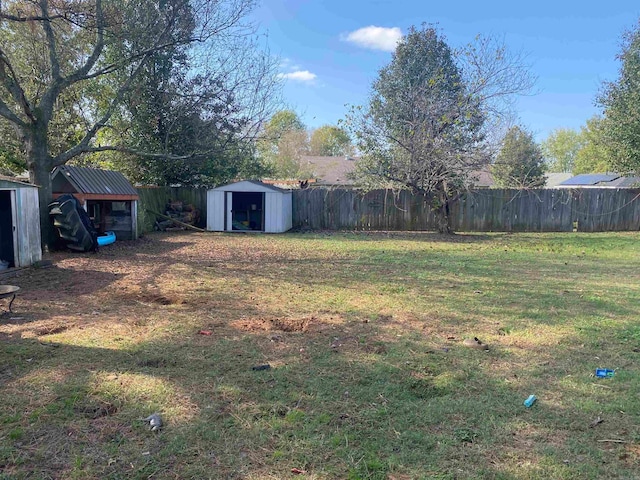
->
0, 177, 42, 269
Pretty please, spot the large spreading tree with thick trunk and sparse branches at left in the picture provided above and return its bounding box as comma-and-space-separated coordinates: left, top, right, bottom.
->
0, 0, 278, 246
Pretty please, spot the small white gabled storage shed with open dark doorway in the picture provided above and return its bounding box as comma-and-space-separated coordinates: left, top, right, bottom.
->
207, 180, 293, 233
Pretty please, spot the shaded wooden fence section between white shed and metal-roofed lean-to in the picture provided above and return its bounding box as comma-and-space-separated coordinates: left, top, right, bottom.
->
136, 187, 207, 233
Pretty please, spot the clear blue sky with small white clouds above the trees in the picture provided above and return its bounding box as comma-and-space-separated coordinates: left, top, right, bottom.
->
254, 0, 640, 140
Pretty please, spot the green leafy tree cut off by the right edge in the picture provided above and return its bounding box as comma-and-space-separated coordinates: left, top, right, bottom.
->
598, 20, 640, 175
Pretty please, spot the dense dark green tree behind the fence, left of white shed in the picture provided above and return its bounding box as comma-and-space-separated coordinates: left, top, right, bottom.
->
88, 69, 266, 186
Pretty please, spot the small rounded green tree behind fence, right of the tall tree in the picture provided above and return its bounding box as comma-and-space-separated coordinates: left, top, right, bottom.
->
491, 126, 545, 188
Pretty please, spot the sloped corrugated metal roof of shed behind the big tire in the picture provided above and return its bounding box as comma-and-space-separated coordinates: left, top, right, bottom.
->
52, 165, 138, 195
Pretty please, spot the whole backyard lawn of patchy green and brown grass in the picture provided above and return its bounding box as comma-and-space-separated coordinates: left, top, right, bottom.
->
0, 233, 640, 480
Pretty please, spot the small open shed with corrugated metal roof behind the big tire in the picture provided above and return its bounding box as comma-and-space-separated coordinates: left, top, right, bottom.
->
51, 165, 139, 240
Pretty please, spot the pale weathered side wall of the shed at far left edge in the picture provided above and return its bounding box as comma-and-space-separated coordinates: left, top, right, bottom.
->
15, 188, 42, 267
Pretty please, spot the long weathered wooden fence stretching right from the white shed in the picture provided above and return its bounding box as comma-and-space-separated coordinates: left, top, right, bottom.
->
293, 188, 640, 232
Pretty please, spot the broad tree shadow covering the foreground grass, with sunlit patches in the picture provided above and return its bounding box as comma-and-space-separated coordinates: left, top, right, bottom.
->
0, 310, 640, 478
